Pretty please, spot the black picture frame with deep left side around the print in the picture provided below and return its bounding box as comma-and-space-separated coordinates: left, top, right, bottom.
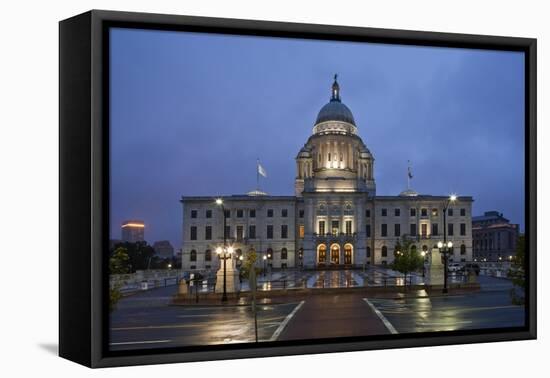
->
59, 10, 537, 367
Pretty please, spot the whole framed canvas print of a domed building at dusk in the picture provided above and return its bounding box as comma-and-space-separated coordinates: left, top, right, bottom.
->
59, 11, 536, 367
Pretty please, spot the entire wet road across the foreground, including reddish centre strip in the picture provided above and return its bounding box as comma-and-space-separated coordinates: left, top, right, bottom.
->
110, 277, 524, 350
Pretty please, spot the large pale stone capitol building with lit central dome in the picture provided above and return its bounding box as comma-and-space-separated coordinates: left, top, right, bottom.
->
181, 77, 473, 270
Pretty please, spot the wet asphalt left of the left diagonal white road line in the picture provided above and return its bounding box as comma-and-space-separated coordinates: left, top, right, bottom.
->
110, 286, 299, 351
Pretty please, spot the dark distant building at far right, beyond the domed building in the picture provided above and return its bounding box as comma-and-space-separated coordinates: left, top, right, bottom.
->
472, 211, 519, 261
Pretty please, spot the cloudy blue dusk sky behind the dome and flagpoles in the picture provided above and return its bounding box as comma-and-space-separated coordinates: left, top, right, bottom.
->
111, 29, 525, 249
